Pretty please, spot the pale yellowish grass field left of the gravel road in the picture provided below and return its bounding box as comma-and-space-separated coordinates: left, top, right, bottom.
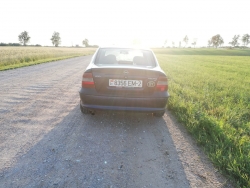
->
0, 47, 96, 71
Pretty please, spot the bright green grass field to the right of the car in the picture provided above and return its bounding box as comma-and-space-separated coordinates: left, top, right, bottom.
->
154, 49, 250, 187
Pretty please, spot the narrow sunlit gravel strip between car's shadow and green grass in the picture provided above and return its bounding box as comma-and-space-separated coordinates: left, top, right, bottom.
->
163, 110, 233, 188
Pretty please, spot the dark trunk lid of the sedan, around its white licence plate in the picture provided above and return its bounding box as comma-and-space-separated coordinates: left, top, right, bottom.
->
92, 67, 164, 97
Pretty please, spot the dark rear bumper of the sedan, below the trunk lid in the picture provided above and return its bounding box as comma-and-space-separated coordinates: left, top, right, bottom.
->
79, 89, 169, 112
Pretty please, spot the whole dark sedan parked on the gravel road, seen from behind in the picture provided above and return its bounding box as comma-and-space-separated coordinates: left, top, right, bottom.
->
79, 47, 169, 116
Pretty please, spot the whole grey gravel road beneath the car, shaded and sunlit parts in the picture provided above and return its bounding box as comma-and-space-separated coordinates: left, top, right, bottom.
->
0, 56, 231, 188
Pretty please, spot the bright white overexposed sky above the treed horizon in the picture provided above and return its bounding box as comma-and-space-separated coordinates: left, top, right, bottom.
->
0, 0, 250, 47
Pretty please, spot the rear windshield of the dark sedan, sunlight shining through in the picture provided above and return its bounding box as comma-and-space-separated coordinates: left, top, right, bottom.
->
95, 48, 156, 67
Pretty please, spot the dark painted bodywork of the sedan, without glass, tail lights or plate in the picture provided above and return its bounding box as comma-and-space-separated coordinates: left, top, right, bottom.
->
79, 48, 169, 113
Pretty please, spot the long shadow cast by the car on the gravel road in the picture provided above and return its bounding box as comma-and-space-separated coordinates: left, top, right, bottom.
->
0, 105, 190, 188
